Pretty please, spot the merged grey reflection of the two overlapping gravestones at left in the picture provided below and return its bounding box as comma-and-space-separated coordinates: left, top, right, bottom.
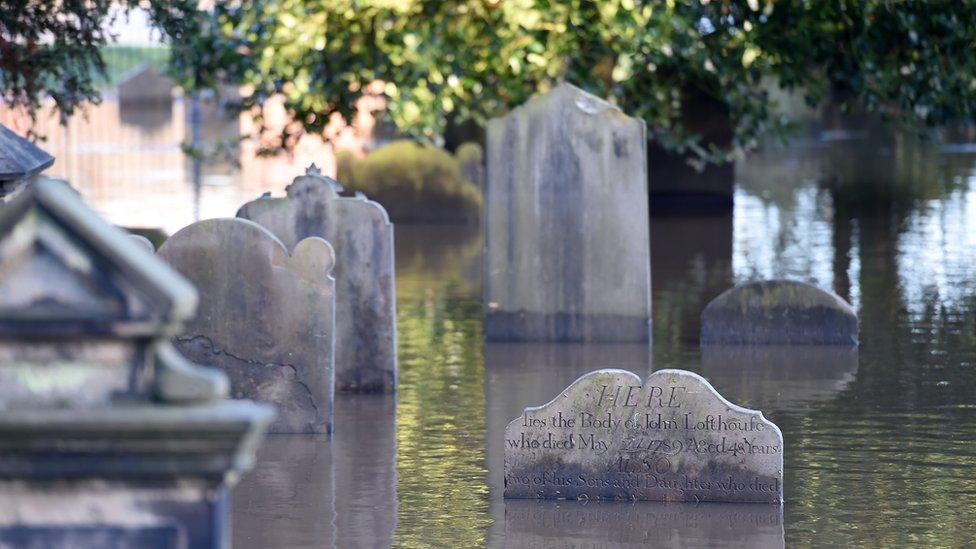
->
232, 395, 397, 547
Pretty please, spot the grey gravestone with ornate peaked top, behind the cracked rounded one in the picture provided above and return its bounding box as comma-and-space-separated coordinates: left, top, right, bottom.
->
237, 165, 397, 393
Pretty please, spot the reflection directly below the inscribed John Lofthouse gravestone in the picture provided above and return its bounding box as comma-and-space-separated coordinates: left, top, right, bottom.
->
505, 499, 786, 549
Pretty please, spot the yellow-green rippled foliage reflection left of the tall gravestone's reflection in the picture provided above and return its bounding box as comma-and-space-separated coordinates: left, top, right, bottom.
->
394, 288, 490, 547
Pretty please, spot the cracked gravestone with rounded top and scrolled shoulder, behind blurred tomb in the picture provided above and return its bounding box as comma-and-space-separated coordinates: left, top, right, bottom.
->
157, 219, 335, 433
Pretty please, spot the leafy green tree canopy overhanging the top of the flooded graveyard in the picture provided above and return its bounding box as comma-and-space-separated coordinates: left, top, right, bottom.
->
0, 0, 976, 161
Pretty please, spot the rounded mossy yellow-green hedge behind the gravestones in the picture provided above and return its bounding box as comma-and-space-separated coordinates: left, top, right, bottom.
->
337, 140, 482, 224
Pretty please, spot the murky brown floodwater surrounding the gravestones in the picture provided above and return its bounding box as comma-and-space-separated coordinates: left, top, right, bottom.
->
24, 99, 976, 548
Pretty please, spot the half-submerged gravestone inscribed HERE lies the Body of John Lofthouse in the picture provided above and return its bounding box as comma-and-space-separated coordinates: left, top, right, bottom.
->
505, 370, 783, 503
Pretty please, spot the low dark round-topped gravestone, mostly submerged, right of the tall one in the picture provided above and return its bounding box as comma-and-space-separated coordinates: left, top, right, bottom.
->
701, 280, 858, 345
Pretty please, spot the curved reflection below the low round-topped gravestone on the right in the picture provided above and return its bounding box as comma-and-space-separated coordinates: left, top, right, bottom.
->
701, 345, 858, 411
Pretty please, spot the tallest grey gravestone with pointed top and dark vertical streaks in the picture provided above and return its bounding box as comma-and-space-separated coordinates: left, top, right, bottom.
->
484, 84, 651, 342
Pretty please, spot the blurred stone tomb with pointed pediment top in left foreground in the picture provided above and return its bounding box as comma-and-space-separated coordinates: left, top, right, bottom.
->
0, 179, 273, 548
